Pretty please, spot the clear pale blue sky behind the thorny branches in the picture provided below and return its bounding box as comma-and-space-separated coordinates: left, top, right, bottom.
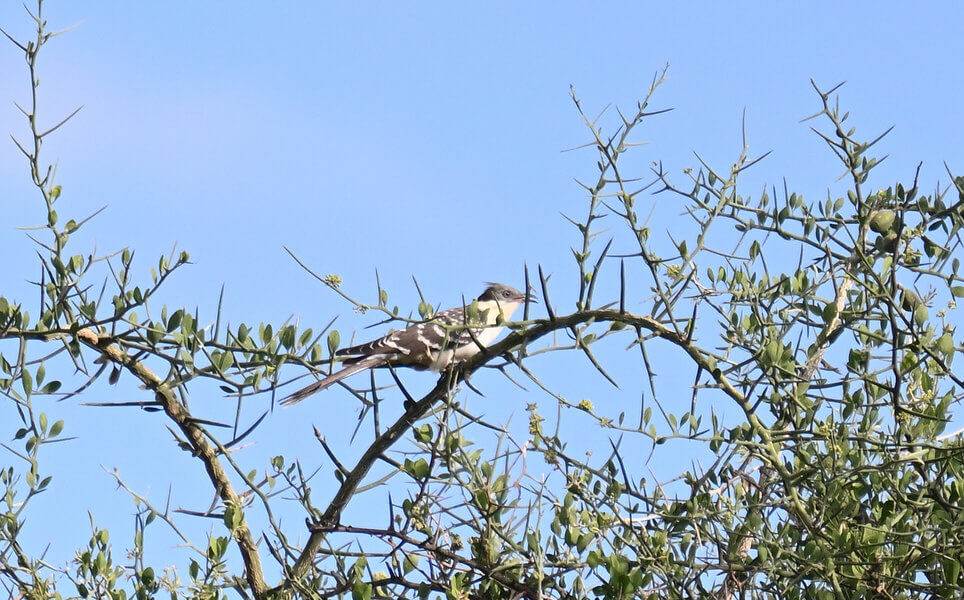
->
0, 0, 964, 584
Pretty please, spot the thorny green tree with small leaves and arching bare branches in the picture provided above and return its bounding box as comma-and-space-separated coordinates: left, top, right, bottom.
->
0, 2, 964, 599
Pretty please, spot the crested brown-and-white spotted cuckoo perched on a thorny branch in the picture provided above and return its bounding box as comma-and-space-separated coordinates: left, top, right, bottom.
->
281, 283, 536, 406
